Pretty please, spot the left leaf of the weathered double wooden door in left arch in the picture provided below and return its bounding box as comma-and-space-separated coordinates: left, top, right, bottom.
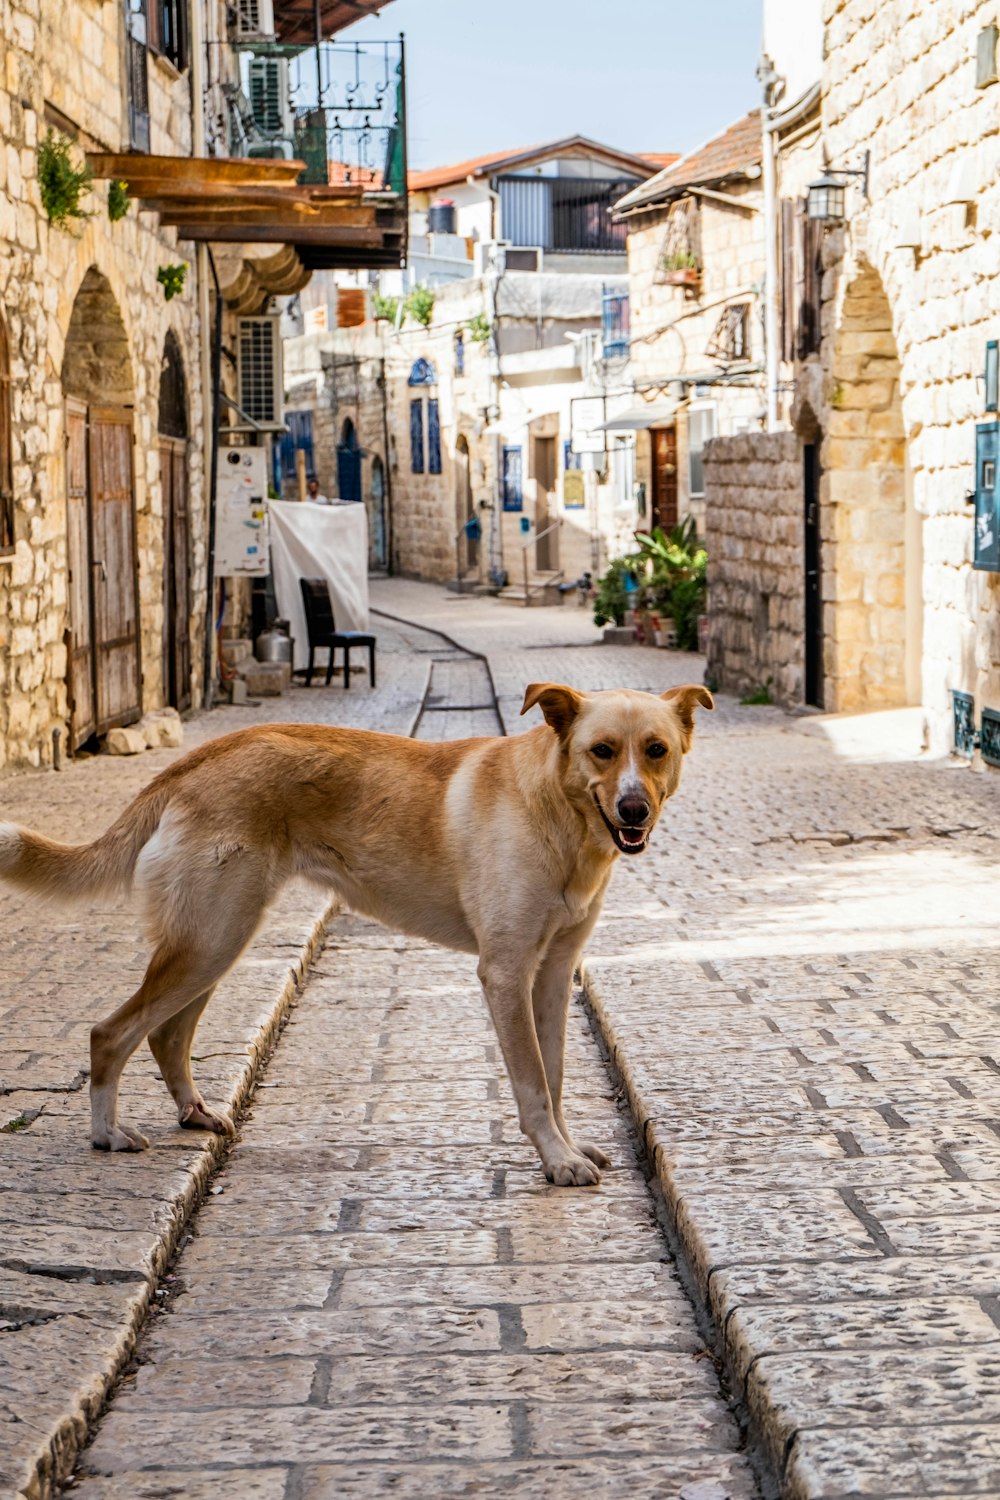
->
66, 399, 97, 752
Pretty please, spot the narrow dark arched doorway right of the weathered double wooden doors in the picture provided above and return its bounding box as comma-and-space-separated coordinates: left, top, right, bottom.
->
157, 333, 190, 713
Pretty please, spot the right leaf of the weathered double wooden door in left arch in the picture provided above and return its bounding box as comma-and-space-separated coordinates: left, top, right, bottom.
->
88, 407, 142, 735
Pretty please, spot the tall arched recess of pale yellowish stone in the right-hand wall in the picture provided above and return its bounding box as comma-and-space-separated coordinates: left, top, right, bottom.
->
820, 266, 922, 713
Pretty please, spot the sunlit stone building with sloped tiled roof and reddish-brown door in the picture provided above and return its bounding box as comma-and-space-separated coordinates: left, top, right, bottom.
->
615, 111, 765, 546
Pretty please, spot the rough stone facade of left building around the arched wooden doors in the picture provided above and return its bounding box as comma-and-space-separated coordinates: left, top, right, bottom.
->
0, 0, 205, 770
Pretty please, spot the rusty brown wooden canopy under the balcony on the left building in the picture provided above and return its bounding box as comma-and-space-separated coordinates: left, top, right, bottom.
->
87, 152, 406, 269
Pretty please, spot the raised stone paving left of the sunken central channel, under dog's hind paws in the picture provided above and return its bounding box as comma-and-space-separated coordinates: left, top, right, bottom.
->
0, 630, 429, 1500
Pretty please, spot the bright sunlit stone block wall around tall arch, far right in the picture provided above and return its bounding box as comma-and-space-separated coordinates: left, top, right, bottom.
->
823, 0, 1000, 750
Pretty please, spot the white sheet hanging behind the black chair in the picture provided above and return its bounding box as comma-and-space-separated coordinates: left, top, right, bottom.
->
267, 500, 369, 671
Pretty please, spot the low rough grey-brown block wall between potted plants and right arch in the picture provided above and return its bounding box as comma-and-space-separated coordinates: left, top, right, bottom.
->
705, 432, 805, 704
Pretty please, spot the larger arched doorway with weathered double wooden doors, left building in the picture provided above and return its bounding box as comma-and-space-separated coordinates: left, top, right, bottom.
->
61, 266, 142, 750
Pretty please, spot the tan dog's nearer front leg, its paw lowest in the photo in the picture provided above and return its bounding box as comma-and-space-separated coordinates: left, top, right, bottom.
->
478, 956, 601, 1188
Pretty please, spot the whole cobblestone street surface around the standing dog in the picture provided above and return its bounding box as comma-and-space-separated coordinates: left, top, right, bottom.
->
0, 581, 1000, 1500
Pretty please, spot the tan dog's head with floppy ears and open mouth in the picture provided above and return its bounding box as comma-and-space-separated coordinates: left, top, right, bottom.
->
522, 683, 715, 854
